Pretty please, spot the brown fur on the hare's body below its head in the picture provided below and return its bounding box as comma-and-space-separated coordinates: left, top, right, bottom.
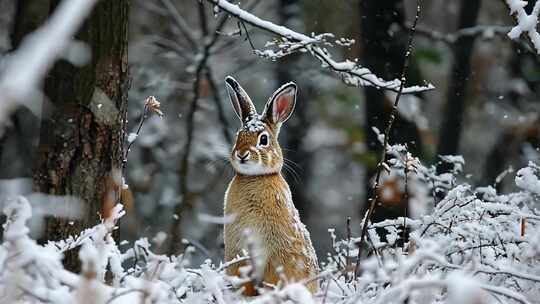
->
225, 174, 318, 292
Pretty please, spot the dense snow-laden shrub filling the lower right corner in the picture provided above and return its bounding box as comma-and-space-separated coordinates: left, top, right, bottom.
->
323, 145, 540, 303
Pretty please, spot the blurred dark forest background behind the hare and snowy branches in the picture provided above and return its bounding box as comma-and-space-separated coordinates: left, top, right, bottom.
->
0, 0, 540, 260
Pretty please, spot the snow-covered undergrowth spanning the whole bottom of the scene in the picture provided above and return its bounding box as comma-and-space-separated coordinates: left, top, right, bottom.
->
0, 151, 540, 304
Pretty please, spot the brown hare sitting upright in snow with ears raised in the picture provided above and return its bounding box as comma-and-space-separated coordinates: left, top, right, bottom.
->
224, 76, 319, 295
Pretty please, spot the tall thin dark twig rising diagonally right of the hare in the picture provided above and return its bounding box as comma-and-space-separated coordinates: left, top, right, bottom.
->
354, 0, 421, 279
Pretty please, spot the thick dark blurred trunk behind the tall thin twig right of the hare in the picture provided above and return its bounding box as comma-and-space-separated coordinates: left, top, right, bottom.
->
360, 0, 422, 221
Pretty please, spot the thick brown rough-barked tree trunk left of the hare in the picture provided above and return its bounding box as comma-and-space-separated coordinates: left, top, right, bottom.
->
33, 0, 129, 271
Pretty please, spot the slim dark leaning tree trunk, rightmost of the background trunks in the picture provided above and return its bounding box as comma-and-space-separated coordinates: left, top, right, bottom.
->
437, 0, 480, 172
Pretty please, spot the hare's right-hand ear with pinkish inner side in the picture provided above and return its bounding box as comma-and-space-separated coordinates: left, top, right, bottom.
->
263, 82, 296, 124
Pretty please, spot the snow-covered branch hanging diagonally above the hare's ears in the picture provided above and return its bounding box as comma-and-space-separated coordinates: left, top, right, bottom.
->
207, 0, 434, 93
